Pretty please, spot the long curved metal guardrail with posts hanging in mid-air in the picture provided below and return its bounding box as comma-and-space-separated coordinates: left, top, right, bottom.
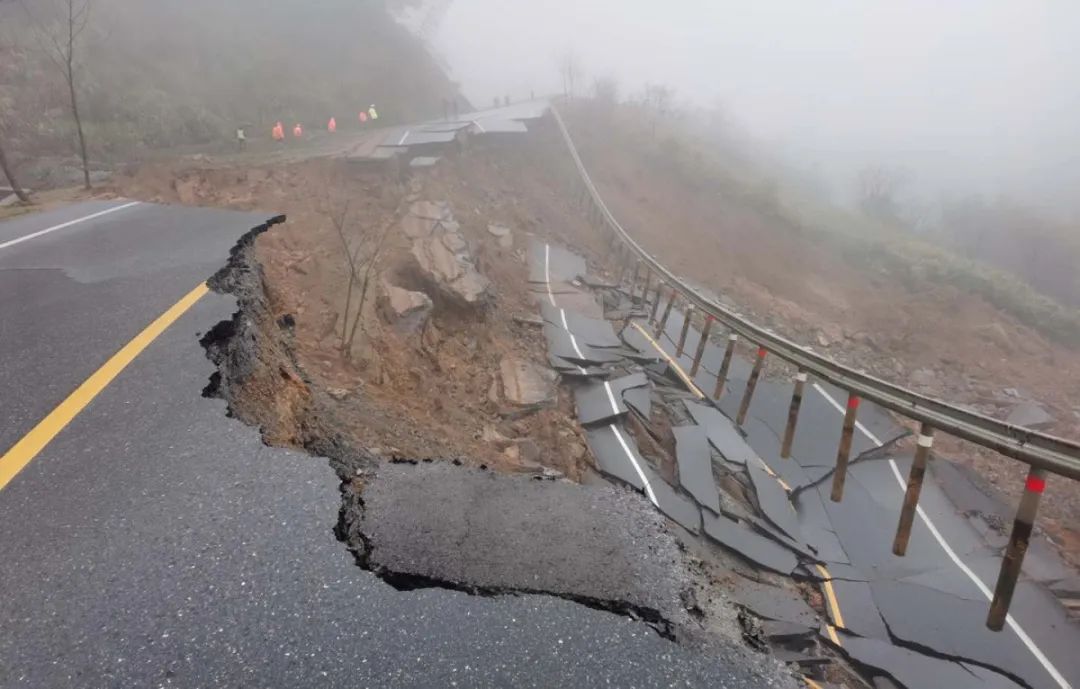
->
551, 105, 1080, 630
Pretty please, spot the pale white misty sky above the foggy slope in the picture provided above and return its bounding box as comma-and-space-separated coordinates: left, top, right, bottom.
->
432, 0, 1080, 213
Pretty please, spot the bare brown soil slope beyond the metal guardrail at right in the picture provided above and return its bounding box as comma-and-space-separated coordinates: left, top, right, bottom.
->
561, 112, 1080, 564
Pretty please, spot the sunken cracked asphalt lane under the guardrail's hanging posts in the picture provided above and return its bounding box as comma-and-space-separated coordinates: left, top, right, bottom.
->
659, 311, 1080, 689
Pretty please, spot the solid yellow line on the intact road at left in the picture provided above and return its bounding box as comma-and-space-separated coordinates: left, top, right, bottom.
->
0, 283, 208, 490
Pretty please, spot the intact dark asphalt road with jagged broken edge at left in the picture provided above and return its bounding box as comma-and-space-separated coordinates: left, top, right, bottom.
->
0, 202, 777, 689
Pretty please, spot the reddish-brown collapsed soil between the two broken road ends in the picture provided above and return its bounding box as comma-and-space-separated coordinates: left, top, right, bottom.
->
113, 130, 617, 479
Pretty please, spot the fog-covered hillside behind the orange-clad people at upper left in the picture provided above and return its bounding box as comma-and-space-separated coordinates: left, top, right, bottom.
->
0, 0, 457, 187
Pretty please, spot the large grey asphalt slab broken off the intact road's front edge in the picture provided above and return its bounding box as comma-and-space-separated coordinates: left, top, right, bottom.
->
359, 462, 688, 636
